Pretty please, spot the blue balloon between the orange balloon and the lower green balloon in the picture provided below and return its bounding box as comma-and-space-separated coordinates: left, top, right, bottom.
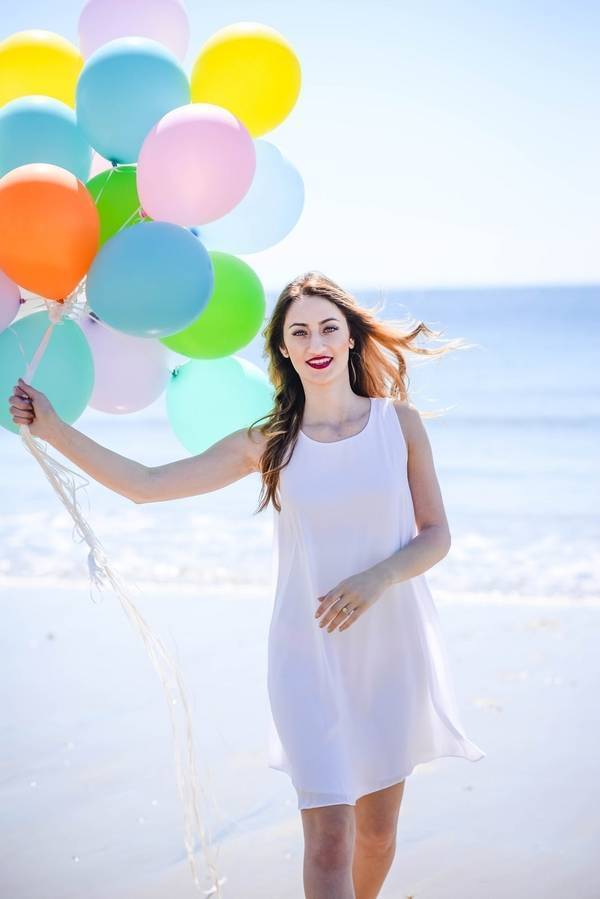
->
87, 222, 213, 337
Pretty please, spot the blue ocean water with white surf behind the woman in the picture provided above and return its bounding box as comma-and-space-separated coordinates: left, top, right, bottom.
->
0, 286, 600, 599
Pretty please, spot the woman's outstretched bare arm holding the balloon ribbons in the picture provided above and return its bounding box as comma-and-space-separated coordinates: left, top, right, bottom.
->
10, 379, 262, 503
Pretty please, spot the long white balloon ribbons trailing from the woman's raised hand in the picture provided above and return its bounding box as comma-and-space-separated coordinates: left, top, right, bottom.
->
11, 285, 227, 897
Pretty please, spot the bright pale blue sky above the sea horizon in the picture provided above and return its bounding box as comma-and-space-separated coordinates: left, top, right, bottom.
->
0, 0, 600, 291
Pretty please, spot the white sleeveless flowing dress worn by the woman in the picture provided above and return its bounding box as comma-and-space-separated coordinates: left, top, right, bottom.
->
267, 397, 485, 809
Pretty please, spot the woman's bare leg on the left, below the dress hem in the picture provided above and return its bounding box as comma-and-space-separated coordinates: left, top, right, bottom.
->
301, 805, 356, 899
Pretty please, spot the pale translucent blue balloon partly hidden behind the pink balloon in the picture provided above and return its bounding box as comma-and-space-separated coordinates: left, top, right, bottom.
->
197, 140, 304, 254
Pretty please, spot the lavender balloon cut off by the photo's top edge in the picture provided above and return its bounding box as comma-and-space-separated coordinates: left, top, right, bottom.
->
79, 0, 190, 59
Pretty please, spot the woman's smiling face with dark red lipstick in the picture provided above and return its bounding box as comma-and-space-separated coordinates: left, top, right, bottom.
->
281, 296, 354, 383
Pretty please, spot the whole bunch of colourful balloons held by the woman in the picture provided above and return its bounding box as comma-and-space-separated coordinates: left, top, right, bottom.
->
0, 0, 304, 889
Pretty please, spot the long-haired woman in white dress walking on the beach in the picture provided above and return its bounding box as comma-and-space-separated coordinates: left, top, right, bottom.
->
10, 272, 485, 899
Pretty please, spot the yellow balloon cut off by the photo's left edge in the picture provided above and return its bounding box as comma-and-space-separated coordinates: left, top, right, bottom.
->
0, 29, 83, 107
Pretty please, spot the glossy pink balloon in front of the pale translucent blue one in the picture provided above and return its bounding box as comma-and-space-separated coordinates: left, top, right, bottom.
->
138, 103, 256, 225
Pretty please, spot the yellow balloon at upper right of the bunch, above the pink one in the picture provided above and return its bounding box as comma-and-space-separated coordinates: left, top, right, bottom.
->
191, 22, 301, 137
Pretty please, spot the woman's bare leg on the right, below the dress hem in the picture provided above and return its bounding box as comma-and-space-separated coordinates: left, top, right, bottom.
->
352, 781, 405, 899
